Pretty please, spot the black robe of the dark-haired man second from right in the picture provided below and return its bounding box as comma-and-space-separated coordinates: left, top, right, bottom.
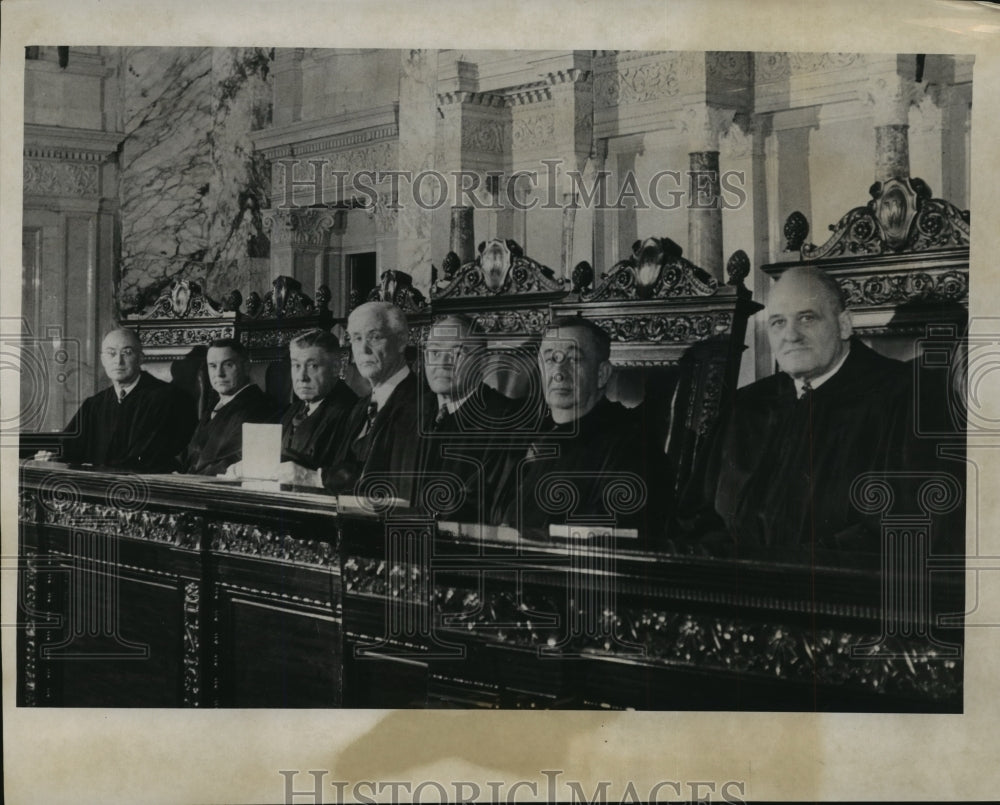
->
501, 397, 673, 547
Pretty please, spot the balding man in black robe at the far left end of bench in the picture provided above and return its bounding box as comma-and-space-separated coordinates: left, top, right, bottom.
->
35, 327, 196, 472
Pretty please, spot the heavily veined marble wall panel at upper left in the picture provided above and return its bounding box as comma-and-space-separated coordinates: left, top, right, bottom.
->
117, 47, 273, 313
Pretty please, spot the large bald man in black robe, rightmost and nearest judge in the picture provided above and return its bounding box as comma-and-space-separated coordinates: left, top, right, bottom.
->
700, 267, 915, 557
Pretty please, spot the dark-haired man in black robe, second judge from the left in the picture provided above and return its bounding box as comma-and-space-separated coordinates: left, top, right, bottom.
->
181, 339, 277, 475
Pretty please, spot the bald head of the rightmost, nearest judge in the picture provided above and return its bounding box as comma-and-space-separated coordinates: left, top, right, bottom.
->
765, 266, 852, 380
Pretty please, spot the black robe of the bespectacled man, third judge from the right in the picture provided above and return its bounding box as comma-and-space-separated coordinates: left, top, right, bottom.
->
416, 383, 521, 522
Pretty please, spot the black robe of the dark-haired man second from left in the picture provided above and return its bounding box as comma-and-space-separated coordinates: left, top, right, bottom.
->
181, 383, 277, 475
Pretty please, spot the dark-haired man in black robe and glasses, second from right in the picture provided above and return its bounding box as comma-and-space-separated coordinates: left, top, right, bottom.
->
501, 318, 672, 547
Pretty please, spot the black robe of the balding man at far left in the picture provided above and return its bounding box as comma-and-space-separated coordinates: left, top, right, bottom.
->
62, 372, 196, 472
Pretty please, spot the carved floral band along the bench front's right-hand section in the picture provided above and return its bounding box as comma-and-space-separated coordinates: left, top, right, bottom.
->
343, 556, 962, 699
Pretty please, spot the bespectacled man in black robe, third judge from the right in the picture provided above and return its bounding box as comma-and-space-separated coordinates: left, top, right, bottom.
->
416, 315, 537, 523
